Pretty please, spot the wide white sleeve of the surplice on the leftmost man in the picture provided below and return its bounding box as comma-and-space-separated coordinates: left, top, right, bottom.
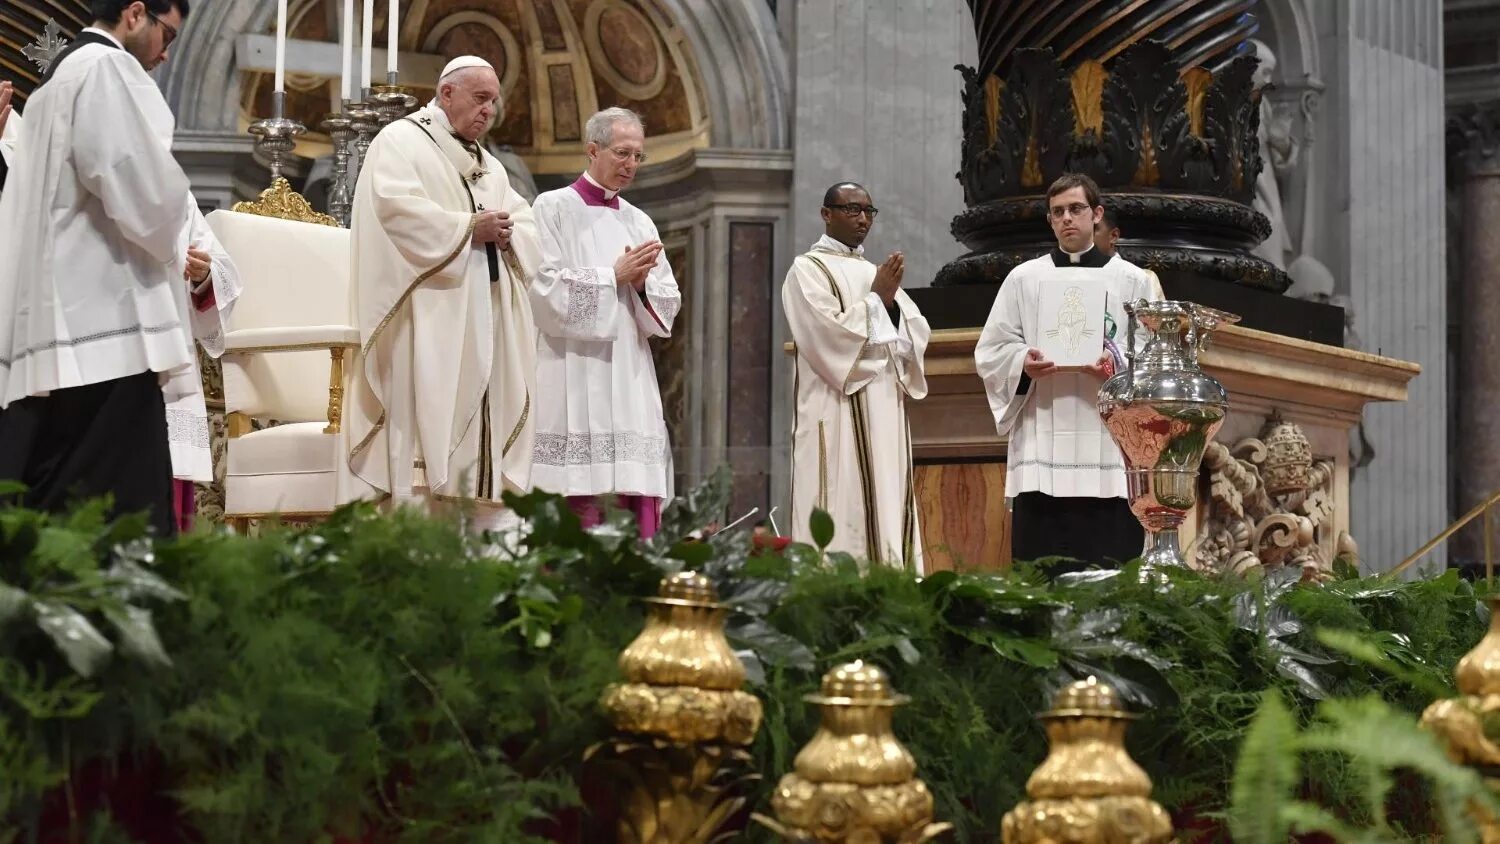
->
72, 51, 191, 263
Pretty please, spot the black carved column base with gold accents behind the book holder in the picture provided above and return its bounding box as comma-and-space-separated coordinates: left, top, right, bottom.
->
933, 40, 1292, 294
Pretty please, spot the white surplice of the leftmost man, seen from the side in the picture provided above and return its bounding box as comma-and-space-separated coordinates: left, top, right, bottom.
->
0, 43, 195, 408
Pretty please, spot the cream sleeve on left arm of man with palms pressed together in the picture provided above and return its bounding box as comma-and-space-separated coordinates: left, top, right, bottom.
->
782, 258, 891, 396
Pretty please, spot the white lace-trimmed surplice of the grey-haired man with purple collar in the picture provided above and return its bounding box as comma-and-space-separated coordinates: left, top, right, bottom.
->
531, 175, 683, 499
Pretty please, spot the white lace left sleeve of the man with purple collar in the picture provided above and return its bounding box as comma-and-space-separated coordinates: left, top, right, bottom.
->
531, 197, 621, 340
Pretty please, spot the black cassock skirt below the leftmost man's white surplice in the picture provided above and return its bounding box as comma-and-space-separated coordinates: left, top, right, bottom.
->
0, 372, 177, 537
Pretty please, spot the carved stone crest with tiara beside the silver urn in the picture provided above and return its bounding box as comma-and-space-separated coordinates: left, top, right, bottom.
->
1190, 415, 1359, 579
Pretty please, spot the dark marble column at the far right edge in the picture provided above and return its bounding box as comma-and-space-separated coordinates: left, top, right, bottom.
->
1449, 102, 1500, 559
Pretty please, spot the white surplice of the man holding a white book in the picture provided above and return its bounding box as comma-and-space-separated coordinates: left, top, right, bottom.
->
974, 249, 1161, 498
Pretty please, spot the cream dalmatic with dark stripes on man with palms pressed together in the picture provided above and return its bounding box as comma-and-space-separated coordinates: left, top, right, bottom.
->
782, 235, 932, 574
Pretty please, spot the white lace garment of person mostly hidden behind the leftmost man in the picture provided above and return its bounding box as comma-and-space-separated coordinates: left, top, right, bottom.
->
162, 207, 240, 483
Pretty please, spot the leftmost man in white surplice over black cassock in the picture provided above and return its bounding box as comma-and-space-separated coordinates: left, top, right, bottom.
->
0, 0, 195, 535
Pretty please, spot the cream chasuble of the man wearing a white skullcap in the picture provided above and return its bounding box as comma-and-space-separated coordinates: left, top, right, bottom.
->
348, 103, 539, 505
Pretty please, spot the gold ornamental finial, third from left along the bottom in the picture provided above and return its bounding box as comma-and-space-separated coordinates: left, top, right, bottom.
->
1002, 676, 1172, 844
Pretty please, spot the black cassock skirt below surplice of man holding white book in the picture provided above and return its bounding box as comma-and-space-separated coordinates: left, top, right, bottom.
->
1011, 492, 1146, 574
